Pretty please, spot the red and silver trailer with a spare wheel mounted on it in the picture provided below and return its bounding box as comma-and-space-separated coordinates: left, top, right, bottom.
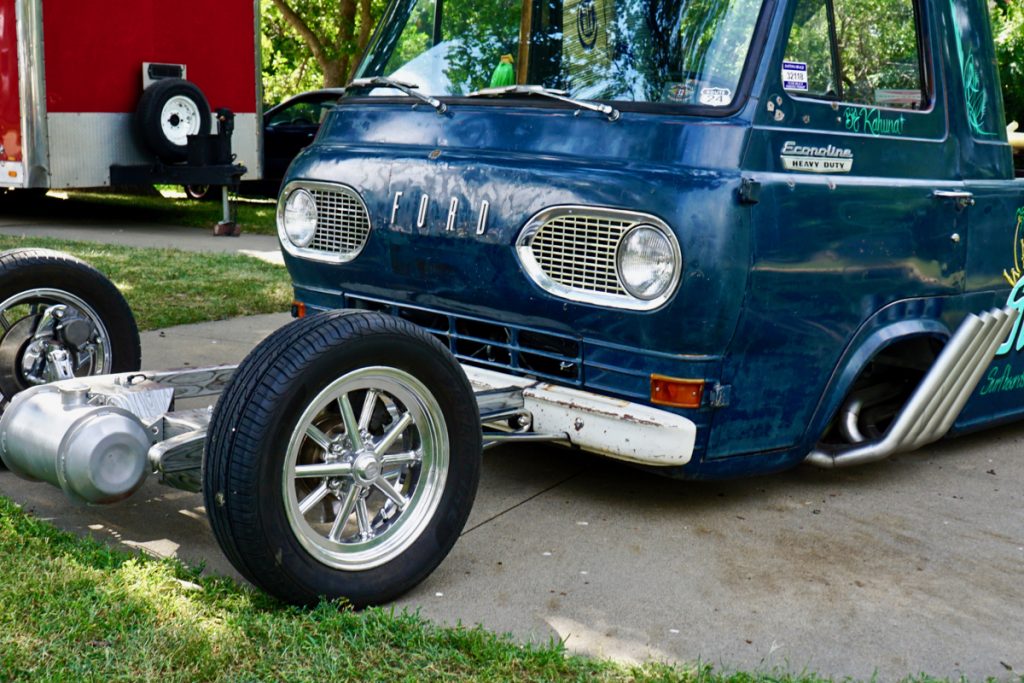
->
0, 0, 262, 192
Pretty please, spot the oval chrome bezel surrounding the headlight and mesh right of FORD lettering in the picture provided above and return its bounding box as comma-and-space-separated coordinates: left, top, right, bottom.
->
515, 205, 683, 311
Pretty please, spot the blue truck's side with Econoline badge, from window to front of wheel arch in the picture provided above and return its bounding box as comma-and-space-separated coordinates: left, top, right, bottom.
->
709, 0, 965, 458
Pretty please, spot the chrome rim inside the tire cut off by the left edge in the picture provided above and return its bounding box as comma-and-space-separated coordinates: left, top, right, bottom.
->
0, 288, 113, 399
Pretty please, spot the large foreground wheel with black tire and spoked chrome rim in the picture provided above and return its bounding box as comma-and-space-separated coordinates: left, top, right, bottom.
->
203, 311, 481, 607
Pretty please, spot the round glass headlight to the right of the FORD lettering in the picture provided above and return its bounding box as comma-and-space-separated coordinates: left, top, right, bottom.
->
615, 225, 679, 301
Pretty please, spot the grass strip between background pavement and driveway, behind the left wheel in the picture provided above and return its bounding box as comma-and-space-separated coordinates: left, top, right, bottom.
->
0, 236, 292, 330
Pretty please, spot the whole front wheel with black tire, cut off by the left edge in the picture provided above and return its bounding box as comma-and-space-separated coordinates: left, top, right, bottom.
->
0, 249, 141, 405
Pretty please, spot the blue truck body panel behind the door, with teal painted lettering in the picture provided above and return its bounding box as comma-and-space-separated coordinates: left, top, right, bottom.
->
945, 0, 1024, 431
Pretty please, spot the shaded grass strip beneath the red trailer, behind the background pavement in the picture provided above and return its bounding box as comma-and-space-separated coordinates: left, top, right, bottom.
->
4, 187, 278, 234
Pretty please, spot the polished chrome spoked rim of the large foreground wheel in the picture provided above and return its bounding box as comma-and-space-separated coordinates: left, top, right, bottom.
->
283, 366, 449, 571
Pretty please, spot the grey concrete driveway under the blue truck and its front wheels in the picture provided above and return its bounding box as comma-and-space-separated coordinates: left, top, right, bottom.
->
0, 315, 1024, 680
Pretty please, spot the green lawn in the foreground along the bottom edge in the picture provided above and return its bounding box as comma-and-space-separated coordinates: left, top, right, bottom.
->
0, 498, 974, 683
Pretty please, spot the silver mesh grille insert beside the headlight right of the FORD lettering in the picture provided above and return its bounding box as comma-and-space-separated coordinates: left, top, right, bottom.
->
529, 214, 635, 296
